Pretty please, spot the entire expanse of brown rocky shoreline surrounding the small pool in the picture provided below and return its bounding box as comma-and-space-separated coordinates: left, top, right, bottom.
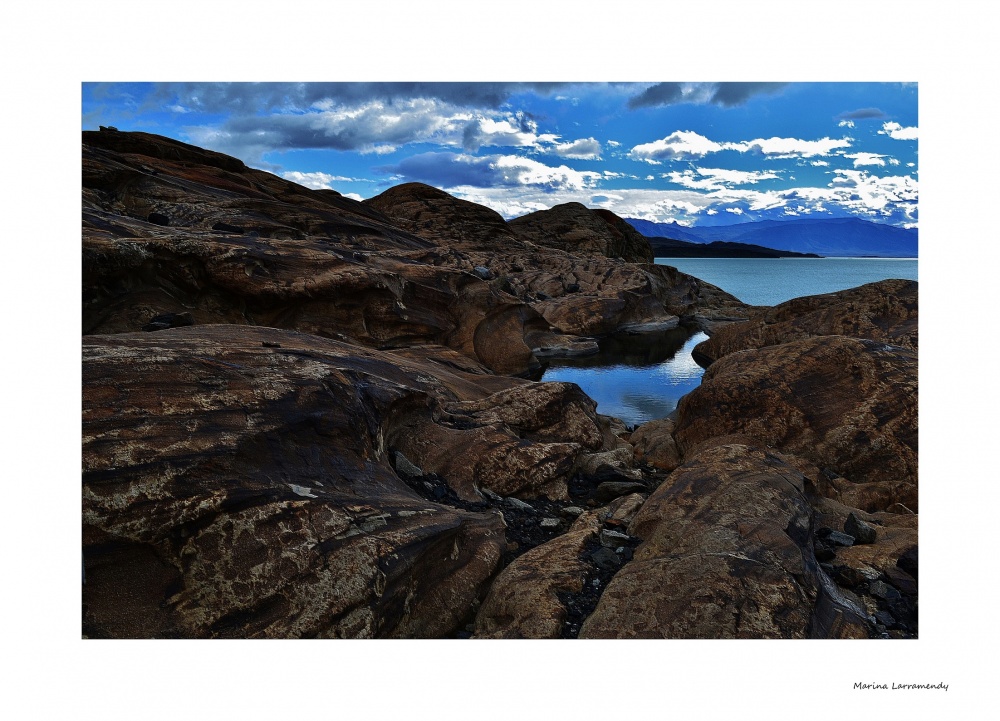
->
82, 129, 918, 638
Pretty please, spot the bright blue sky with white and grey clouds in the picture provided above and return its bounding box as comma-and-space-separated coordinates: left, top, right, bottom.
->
83, 82, 918, 227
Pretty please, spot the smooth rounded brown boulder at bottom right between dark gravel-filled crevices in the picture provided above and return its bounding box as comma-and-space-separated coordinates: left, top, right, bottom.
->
580, 444, 867, 638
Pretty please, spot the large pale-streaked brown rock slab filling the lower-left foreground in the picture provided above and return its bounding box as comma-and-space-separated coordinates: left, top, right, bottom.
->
83, 326, 600, 637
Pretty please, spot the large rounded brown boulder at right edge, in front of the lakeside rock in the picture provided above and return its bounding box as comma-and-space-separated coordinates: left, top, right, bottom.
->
674, 336, 917, 511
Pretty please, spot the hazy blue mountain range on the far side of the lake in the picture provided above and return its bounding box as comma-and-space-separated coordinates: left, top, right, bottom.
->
625, 218, 917, 258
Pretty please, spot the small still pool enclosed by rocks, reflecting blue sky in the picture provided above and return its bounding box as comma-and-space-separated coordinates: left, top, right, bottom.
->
542, 328, 708, 425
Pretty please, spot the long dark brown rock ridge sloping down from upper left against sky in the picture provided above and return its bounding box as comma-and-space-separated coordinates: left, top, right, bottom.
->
83, 131, 746, 374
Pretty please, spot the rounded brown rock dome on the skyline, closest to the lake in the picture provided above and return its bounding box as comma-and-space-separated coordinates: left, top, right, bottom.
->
509, 203, 653, 263
